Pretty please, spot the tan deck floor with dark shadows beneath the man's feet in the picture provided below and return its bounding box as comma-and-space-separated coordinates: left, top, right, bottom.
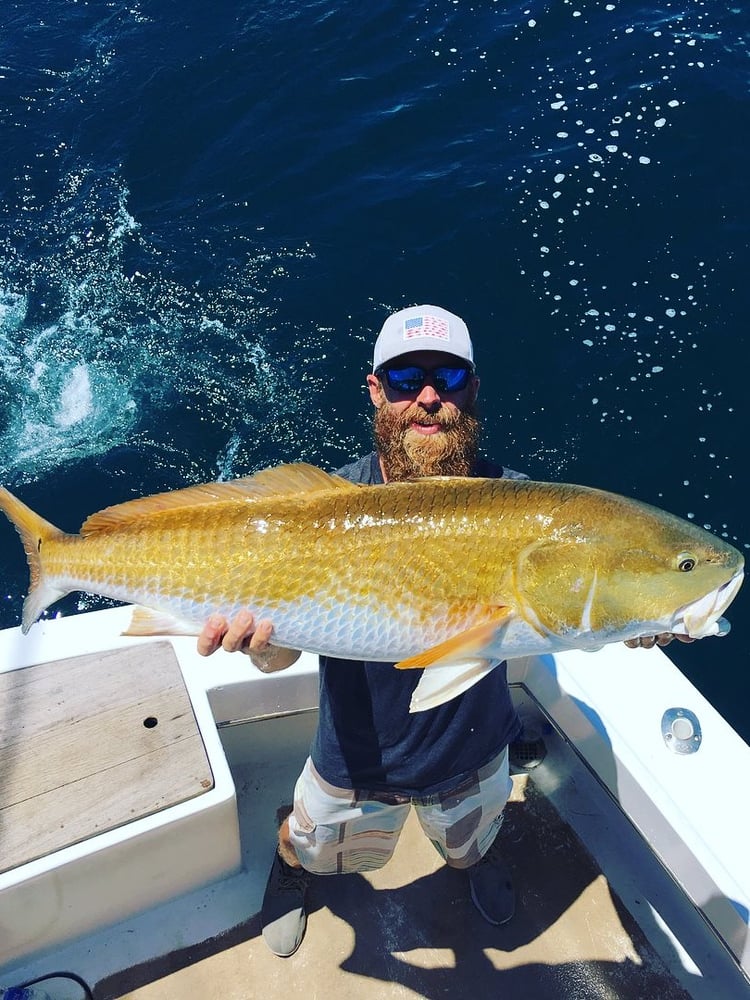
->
95, 715, 692, 1000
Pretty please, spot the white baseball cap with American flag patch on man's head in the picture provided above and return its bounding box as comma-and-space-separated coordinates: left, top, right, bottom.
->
372, 306, 474, 371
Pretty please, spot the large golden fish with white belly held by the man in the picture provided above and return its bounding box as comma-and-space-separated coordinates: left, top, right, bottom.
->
0, 465, 744, 710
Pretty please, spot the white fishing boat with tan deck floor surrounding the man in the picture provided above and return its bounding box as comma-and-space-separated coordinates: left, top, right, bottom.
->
0, 609, 750, 1000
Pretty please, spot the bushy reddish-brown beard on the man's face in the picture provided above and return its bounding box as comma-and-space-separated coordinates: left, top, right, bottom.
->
373, 404, 480, 482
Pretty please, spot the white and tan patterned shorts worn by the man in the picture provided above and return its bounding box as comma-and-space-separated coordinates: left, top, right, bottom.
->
289, 748, 512, 875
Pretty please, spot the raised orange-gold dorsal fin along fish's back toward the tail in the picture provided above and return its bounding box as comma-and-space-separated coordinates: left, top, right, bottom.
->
81, 462, 360, 535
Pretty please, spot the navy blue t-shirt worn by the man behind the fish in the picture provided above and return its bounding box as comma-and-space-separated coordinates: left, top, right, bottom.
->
311, 452, 526, 795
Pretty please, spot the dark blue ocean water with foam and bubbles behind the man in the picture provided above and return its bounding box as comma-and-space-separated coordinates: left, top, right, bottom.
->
0, 0, 750, 738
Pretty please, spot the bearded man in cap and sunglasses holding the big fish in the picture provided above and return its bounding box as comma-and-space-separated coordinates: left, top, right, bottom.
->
198, 306, 526, 957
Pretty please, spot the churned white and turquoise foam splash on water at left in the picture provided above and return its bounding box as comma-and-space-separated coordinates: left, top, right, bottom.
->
0, 165, 357, 486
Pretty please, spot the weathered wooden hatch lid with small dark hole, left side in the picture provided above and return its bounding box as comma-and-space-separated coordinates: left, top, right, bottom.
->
0, 642, 214, 873
